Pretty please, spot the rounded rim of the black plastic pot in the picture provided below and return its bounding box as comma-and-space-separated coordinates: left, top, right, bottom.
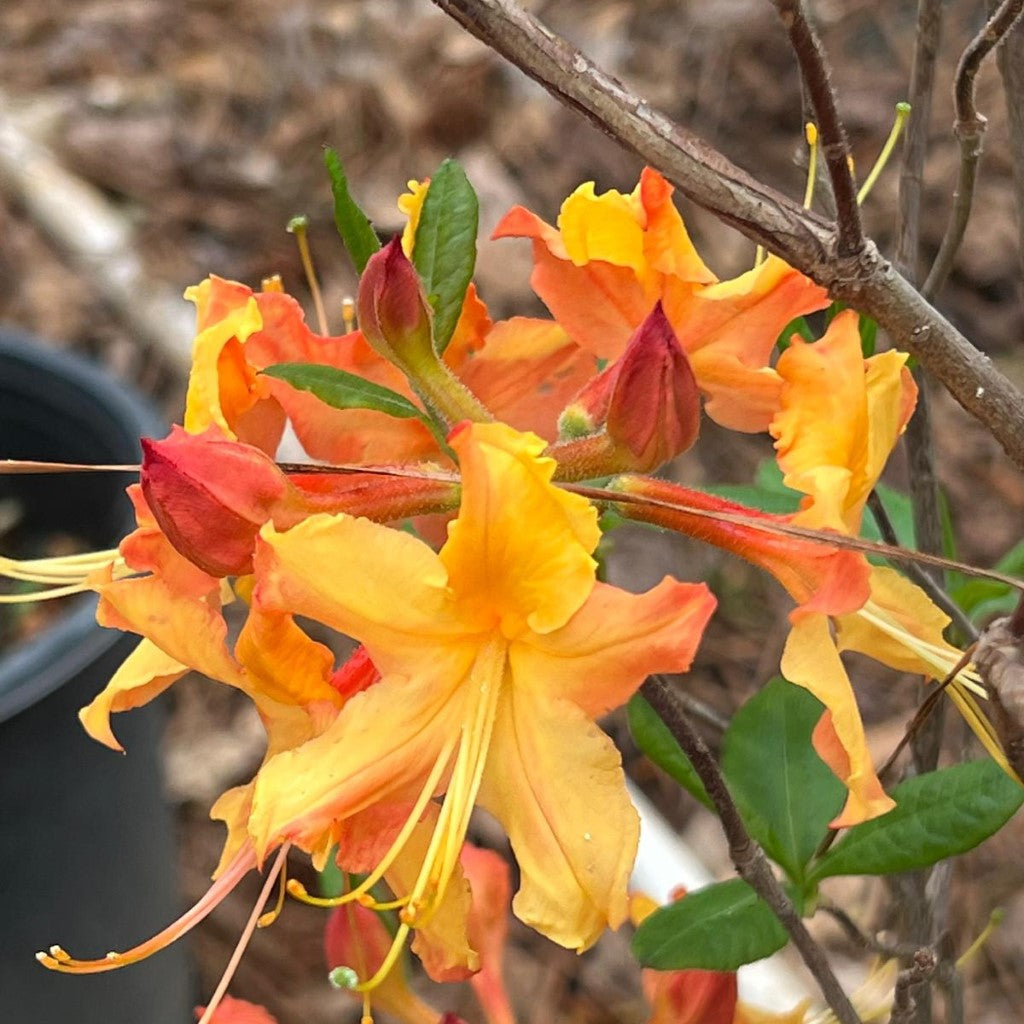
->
0, 325, 166, 722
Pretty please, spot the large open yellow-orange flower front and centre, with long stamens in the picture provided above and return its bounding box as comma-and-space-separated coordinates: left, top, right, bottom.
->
249, 424, 714, 949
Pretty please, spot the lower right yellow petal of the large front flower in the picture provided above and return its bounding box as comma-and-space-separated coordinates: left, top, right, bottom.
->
479, 685, 639, 950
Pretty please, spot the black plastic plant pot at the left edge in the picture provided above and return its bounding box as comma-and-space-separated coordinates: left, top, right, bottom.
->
0, 331, 191, 1024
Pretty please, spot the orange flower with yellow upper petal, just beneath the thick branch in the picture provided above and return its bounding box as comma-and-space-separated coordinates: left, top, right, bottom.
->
494, 167, 828, 431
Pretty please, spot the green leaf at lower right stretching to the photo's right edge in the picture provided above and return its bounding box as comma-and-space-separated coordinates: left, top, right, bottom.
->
811, 759, 1024, 882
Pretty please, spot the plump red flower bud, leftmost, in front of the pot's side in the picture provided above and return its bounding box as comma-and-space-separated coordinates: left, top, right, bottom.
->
141, 427, 289, 577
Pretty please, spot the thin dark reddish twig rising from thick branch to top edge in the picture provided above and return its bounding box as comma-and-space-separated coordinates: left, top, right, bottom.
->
772, 0, 864, 256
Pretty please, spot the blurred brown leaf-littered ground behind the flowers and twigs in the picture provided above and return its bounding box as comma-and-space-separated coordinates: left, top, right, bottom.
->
0, 0, 1024, 1024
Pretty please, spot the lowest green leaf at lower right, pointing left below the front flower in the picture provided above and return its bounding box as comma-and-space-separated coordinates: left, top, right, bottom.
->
633, 879, 787, 971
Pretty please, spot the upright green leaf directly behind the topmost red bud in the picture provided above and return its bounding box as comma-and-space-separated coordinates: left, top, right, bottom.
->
413, 160, 479, 354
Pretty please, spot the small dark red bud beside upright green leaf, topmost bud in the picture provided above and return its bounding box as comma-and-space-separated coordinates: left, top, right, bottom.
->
356, 238, 436, 373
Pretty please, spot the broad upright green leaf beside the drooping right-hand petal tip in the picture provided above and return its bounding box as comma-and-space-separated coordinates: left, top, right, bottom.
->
722, 677, 846, 882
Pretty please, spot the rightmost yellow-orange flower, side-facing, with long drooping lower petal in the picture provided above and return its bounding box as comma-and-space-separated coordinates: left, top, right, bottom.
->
770, 310, 997, 827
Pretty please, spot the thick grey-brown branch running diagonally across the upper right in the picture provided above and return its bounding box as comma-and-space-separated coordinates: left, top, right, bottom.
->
433, 0, 1024, 469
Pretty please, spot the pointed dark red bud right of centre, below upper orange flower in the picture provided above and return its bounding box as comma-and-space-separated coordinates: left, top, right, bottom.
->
567, 302, 700, 471
